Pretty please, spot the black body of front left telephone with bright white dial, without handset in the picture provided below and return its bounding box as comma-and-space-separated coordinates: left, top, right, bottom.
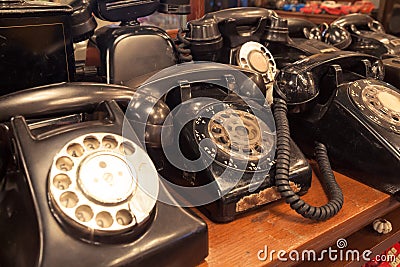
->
0, 101, 208, 266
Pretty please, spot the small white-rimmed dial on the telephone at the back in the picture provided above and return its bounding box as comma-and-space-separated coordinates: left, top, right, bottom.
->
237, 42, 276, 83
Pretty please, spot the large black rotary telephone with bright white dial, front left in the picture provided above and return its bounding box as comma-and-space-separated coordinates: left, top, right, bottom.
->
0, 83, 208, 266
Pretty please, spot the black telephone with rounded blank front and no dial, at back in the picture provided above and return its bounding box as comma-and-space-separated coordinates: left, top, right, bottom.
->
93, 0, 185, 84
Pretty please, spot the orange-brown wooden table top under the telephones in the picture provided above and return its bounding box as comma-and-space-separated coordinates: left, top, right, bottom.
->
197, 169, 400, 267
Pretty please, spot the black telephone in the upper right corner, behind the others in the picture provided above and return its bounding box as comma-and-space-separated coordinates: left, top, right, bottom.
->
330, 14, 400, 88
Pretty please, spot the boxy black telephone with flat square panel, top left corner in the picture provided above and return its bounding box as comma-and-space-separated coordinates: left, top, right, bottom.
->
0, 0, 97, 95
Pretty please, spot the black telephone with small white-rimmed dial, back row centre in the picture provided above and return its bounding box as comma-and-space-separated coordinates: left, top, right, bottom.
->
185, 8, 276, 101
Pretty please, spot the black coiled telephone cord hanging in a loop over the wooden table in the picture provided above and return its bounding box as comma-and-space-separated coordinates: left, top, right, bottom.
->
273, 98, 344, 221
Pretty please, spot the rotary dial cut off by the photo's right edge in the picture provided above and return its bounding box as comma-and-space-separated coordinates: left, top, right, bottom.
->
349, 80, 400, 134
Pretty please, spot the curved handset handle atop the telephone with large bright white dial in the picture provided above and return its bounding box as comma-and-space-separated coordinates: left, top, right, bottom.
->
0, 83, 135, 122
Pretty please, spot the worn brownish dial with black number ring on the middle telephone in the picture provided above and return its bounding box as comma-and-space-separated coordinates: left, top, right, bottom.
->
194, 104, 275, 171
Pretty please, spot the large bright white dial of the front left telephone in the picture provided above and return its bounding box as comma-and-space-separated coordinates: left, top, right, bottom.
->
48, 133, 158, 235
